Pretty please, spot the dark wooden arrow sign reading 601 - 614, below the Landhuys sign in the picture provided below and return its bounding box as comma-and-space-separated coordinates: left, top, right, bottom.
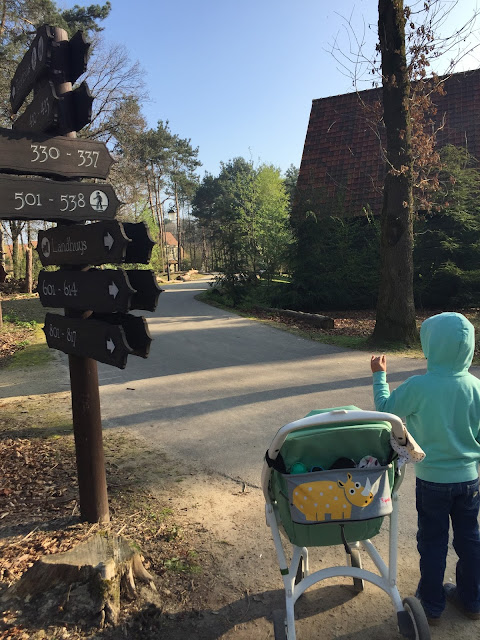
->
38, 269, 135, 313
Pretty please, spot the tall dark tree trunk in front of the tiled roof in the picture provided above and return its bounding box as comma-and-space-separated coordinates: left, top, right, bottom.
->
372, 0, 418, 345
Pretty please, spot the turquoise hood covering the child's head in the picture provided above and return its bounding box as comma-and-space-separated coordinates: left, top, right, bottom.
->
420, 313, 475, 375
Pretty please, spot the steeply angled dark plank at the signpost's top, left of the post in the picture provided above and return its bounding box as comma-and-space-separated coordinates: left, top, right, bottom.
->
10, 25, 55, 113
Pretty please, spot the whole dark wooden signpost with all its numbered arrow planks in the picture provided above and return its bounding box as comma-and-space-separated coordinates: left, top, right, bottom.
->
0, 25, 161, 522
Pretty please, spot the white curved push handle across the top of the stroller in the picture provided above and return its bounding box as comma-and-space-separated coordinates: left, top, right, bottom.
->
268, 409, 407, 460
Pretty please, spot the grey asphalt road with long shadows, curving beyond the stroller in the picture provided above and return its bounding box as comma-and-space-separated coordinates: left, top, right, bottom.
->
92, 281, 430, 486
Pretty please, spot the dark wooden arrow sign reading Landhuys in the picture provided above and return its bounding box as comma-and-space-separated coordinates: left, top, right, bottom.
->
37, 220, 130, 267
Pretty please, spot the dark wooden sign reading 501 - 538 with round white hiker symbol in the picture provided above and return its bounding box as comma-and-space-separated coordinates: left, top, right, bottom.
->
0, 175, 121, 222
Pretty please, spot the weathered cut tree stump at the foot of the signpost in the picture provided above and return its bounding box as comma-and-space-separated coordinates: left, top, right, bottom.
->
2, 533, 156, 627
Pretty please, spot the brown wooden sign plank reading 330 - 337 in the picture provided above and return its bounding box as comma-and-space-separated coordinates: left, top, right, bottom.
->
0, 128, 114, 180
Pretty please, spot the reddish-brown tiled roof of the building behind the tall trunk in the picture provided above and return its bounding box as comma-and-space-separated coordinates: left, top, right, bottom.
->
297, 69, 480, 217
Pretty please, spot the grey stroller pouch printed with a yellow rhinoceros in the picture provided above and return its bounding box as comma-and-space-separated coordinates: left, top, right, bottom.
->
283, 465, 392, 524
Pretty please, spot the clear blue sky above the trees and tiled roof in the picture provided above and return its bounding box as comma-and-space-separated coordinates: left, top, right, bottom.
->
64, 0, 479, 176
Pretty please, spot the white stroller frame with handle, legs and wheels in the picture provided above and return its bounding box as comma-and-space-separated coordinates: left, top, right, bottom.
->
262, 409, 430, 640
